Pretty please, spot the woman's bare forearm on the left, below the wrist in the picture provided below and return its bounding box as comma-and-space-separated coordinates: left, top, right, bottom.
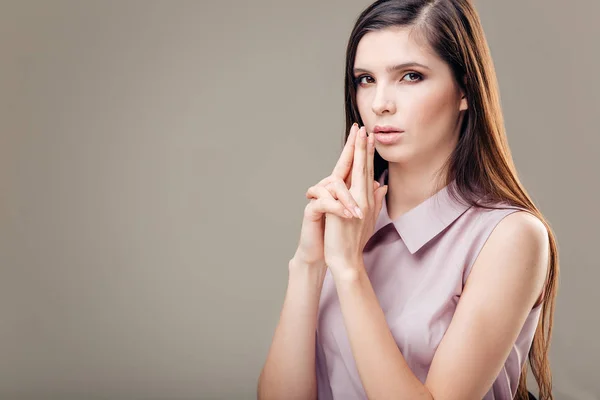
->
257, 259, 327, 400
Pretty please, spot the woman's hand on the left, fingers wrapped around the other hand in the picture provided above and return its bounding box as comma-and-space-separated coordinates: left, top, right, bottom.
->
294, 124, 378, 268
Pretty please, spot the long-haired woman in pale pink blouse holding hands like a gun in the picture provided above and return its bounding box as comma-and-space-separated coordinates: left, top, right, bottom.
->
258, 0, 558, 400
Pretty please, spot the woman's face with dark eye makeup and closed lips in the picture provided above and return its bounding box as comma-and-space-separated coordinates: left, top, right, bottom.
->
354, 27, 467, 166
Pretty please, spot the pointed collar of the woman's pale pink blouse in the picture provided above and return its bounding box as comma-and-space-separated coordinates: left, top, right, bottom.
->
373, 169, 471, 254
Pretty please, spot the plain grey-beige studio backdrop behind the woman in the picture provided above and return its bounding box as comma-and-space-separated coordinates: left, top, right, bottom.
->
0, 0, 600, 400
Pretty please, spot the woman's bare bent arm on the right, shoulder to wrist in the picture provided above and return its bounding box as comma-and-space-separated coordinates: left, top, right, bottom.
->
330, 211, 549, 400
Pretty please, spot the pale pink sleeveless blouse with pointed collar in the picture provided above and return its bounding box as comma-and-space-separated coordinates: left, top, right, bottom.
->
316, 170, 541, 400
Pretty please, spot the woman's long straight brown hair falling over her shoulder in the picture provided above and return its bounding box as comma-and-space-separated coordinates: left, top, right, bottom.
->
344, 0, 559, 400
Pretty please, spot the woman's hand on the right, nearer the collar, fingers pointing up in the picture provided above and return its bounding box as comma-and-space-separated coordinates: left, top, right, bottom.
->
324, 127, 387, 277
